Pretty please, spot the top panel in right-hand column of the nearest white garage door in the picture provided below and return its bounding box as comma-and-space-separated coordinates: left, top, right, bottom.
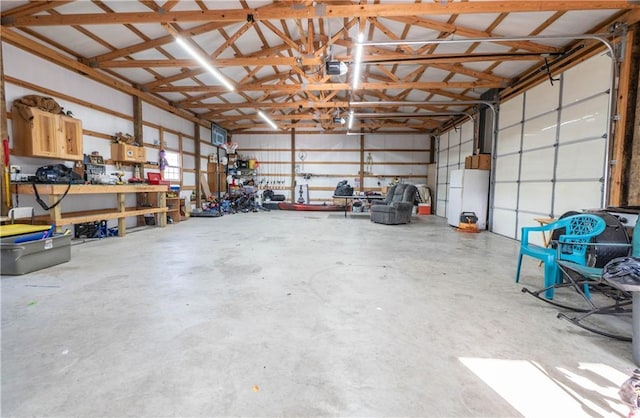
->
562, 54, 611, 106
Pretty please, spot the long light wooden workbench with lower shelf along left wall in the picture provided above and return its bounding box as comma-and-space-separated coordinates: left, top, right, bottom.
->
12, 183, 169, 237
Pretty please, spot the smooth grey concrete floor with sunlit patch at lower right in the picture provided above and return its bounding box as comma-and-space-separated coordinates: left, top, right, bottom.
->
1, 211, 634, 417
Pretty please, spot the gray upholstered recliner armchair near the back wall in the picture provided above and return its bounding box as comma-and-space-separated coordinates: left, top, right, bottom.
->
371, 183, 418, 225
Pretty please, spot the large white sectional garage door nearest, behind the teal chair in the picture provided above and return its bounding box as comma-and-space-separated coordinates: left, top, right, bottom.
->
492, 55, 611, 239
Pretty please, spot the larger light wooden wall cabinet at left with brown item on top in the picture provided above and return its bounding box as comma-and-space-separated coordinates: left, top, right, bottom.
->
12, 106, 84, 160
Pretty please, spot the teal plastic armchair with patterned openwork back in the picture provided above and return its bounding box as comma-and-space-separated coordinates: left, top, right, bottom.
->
516, 213, 607, 299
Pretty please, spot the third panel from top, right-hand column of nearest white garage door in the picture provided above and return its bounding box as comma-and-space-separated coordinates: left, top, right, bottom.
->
556, 138, 605, 180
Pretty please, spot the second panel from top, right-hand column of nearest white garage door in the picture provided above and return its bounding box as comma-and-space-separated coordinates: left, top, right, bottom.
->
559, 95, 609, 143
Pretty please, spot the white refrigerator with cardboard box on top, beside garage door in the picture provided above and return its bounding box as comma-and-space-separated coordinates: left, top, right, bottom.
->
447, 169, 489, 230
